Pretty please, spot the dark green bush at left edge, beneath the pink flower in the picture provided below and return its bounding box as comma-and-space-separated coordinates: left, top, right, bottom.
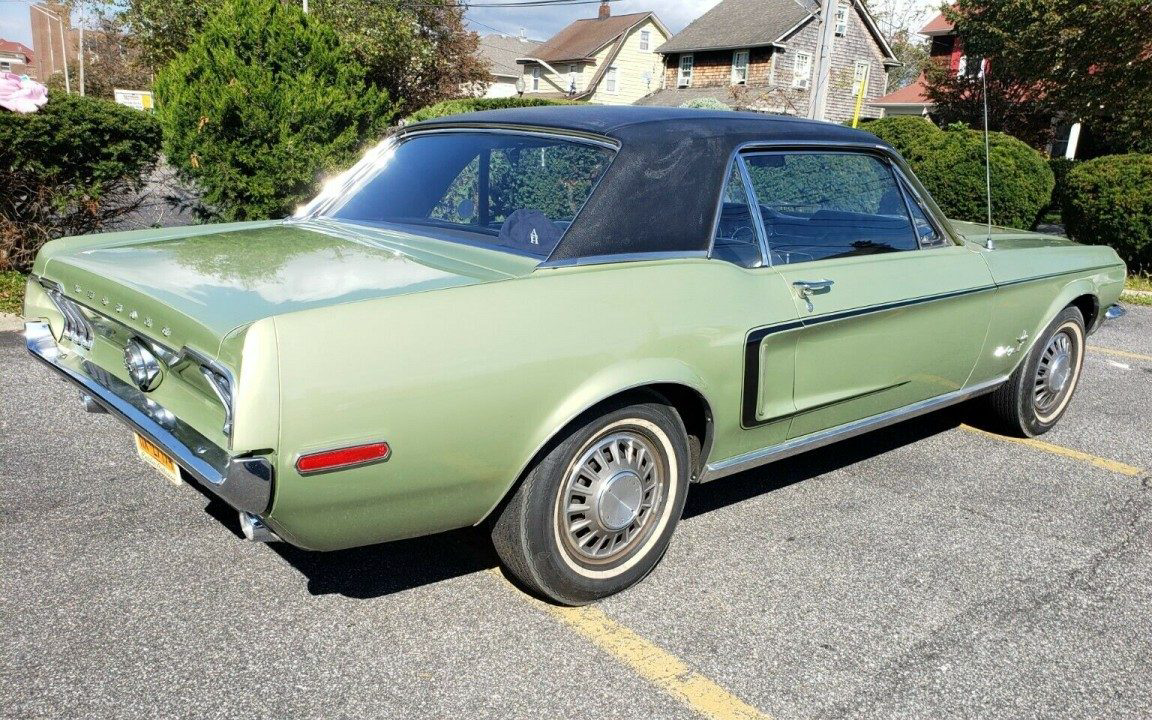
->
0, 93, 160, 271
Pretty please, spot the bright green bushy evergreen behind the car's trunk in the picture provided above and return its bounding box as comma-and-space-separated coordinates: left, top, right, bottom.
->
156, 0, 393, 220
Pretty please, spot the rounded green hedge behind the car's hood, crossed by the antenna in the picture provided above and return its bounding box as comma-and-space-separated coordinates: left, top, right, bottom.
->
862, 118, 1055, 228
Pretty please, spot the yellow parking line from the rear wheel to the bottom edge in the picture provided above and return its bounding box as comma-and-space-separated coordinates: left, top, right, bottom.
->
492, 568, 772, 720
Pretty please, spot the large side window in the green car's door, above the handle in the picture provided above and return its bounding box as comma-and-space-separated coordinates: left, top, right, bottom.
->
745, 152, 926, 265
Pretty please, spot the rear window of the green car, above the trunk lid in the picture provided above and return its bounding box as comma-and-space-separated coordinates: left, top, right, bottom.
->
325, 132, 614, 257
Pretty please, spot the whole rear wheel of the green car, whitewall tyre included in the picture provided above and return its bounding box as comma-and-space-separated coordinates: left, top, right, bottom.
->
492, 401, 689, 605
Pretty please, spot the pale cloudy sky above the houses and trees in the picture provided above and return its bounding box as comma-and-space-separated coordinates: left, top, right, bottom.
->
0, 0, 940, 60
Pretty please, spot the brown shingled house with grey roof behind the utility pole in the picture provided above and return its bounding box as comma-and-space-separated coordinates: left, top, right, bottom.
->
636, 0, 900, 122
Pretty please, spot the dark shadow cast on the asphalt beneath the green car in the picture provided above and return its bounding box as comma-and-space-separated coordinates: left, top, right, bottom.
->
214, 410, 964, 599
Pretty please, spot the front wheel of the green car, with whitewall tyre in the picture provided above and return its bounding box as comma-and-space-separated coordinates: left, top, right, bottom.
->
988, 308, 1085, 438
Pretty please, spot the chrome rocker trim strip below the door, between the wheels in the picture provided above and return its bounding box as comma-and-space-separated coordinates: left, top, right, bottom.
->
699, 376, 1008, 483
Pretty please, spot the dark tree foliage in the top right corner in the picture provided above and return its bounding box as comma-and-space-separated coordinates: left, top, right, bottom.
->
929, 0, 1152, 150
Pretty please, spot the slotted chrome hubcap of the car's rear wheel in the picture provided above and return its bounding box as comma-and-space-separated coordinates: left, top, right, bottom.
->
556, 431, 667, 563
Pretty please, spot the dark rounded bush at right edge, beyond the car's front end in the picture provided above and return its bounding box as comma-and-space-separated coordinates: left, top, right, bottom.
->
1062, 154, 1152, 272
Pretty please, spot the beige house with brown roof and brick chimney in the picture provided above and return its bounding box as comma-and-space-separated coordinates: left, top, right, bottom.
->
516, 2, 672, 105
